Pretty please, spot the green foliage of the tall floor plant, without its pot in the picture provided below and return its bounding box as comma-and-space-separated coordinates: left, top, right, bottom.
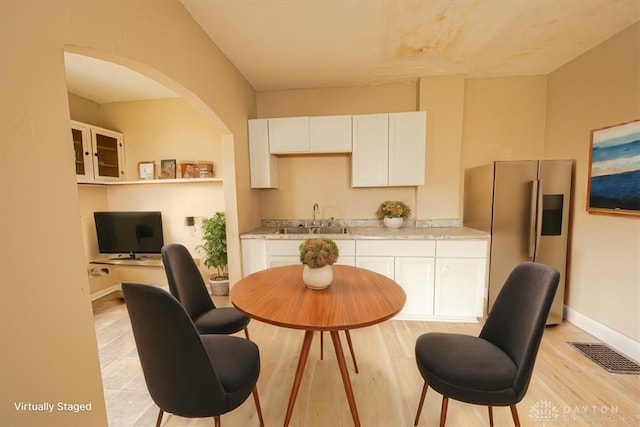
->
197, 212, 228, 279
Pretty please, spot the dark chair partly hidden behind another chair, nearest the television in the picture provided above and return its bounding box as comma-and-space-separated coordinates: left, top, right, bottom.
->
162, 243, 249, 338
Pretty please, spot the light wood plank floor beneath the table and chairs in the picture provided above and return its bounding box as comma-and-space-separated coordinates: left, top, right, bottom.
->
93, 293, 640, 427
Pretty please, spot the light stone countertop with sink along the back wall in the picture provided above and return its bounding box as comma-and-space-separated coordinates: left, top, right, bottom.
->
240, 226, 489, 240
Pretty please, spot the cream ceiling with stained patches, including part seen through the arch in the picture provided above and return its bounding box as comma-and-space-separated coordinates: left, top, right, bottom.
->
65, 0, 640, 103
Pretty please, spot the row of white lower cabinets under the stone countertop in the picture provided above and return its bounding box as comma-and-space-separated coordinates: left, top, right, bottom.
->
242, 239, 487, 321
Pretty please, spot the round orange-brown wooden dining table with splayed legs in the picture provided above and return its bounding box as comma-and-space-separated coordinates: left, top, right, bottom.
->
229, 264, 407, 426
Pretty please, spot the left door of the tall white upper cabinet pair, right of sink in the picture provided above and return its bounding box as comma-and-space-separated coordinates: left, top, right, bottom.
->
351, 114, 389, 187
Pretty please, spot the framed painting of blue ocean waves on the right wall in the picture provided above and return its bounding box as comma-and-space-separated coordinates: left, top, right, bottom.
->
587, 120, 640, 216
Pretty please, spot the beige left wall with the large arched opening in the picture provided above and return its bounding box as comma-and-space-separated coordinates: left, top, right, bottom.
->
0, 0, 259, 425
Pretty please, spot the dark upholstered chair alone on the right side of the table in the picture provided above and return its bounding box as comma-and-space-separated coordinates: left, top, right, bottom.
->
414, 262, 560, 426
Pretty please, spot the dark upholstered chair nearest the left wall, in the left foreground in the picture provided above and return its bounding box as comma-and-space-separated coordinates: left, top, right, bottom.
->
122, 283, 264, 426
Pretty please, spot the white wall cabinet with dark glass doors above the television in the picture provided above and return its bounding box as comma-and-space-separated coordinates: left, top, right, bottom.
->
71, 121, 124, 183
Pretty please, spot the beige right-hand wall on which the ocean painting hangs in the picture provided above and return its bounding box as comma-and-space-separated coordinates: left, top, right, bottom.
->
544, 24, 640, 341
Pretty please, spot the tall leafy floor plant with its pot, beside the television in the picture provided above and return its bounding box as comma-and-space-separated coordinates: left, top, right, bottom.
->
197, 212, 229, 295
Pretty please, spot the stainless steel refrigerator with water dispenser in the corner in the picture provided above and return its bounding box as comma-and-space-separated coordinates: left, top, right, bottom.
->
463, 160, 573, 325
